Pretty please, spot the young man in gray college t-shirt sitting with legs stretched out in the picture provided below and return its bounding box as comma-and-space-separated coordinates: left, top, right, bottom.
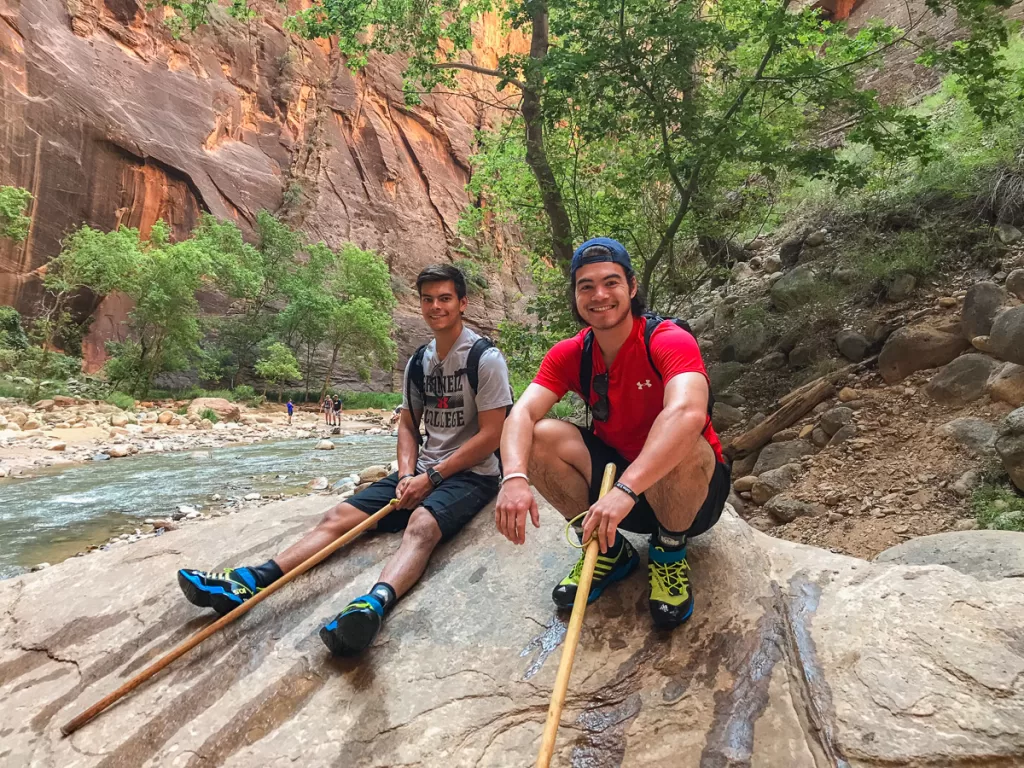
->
178, 265, 512, 655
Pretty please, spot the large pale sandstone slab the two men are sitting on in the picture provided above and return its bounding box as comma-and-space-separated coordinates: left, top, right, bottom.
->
0, 498, 1024, 768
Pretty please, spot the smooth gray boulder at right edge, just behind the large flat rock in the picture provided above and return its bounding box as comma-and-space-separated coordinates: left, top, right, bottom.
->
874, 530, 1024, 582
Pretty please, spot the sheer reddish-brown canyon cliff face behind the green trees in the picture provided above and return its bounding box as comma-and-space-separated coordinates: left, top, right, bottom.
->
0, 0, 523, 382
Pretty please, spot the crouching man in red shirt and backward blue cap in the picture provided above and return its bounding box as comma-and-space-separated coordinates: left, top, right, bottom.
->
495, 238, 729, 628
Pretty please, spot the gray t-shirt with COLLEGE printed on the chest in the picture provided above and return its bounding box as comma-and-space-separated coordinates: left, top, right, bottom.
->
401, 328, 512, 476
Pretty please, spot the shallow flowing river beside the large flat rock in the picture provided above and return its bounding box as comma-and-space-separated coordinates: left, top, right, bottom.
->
0, 435, 395, 579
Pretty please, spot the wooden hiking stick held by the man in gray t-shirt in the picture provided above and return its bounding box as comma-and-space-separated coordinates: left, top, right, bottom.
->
60, 499, 398, 736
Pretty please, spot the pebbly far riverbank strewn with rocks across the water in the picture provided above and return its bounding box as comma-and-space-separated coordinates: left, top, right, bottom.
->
0, 397, 393, 480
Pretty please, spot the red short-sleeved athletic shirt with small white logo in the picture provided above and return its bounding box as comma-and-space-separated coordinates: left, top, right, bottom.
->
534, 317, 722, 462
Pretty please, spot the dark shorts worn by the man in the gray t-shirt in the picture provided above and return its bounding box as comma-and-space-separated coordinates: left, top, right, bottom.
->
347, 472, 498, 542
